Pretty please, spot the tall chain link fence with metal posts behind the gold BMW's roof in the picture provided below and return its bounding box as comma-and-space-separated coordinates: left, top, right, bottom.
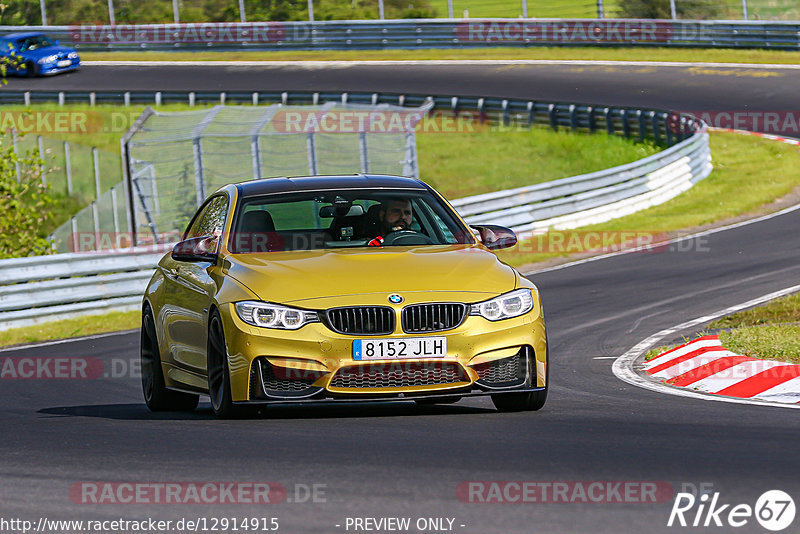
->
121, 102, 432, 244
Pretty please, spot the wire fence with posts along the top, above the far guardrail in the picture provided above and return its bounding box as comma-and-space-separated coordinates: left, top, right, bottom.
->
10, 0, 800, 26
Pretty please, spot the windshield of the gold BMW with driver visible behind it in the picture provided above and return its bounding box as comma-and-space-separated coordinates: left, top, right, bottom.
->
228, 189, 475, 253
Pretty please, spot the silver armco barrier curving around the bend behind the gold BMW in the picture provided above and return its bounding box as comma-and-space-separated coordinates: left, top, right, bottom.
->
0, 92, 711, 330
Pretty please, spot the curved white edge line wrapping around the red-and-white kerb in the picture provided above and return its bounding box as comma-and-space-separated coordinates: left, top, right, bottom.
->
611, 285, 800, 408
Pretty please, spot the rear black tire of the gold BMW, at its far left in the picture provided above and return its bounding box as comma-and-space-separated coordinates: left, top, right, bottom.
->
139, 306, 200, 412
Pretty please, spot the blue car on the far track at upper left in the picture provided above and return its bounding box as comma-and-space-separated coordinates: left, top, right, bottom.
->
0, 32, 81, 76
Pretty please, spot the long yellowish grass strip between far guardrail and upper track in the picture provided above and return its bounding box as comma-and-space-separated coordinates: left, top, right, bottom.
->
81, 46, 800, 65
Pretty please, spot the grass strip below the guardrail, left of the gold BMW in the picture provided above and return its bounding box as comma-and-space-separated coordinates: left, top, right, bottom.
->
0, 311, 141, 347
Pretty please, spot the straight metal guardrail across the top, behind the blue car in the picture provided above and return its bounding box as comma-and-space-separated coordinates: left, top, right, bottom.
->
0, 19, 800, 51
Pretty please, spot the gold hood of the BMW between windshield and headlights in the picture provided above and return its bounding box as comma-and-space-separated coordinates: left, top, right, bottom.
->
226, 245, 517, 307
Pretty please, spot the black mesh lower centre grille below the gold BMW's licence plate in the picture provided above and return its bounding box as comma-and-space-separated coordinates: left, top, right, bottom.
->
330, 362, 469, 389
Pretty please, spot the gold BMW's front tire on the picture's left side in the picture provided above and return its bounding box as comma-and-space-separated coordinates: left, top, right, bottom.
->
206, 310, 244, 419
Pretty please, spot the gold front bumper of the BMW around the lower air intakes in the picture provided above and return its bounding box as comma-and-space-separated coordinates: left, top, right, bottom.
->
220, 306, 547, 404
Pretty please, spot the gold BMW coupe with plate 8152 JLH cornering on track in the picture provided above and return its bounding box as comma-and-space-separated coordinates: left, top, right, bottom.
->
141, 175, 549, 417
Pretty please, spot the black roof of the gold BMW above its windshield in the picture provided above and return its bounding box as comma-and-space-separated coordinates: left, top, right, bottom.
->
236, 174, 428, 197
